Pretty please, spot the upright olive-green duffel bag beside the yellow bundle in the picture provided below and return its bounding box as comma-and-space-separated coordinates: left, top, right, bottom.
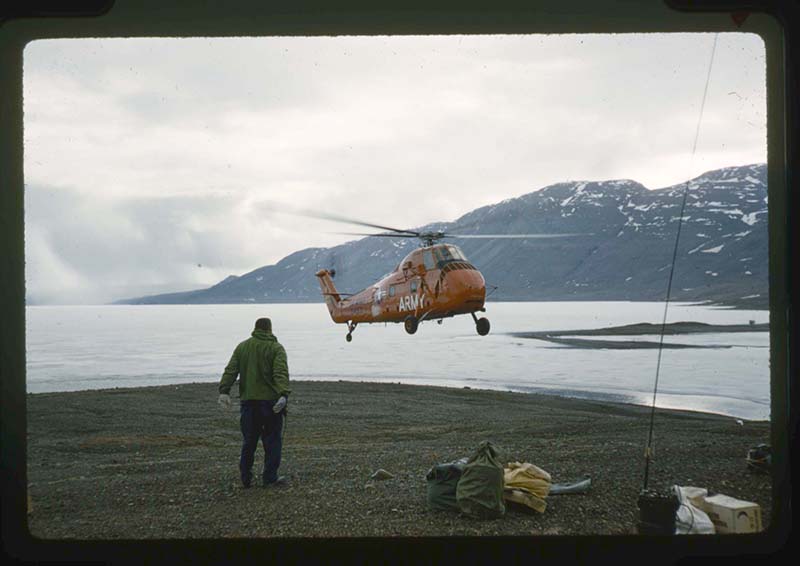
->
456, 440, 506, 519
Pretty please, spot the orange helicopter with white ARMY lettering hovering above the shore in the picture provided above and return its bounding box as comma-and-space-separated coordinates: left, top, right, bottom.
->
300, 214, 575, 342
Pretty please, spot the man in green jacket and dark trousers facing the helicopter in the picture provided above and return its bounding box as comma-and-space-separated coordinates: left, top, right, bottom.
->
219, 318, 290, 488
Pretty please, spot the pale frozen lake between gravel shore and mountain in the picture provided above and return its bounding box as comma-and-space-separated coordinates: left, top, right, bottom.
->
26, 302, 770, 420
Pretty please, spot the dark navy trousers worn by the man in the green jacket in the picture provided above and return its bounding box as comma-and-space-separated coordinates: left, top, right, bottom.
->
239, 401, 283, 485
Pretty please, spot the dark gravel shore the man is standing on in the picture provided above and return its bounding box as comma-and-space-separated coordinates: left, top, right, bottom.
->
28, 381, 771, 540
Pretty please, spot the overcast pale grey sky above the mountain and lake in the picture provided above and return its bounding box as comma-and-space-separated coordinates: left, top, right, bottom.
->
24, 33, 766, 304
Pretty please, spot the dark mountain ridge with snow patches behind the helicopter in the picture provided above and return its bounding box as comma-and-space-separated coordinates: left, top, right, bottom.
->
121, 164, 768, 308
